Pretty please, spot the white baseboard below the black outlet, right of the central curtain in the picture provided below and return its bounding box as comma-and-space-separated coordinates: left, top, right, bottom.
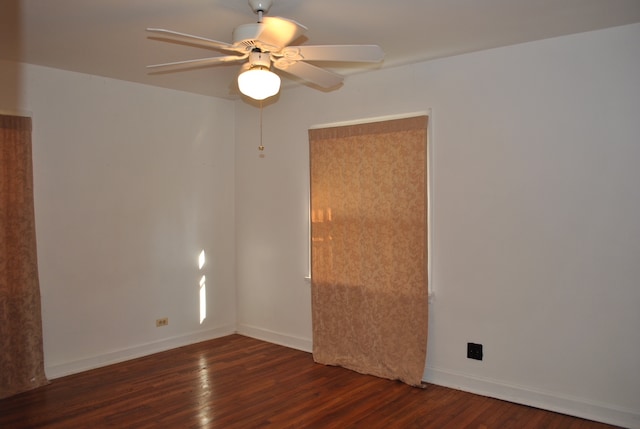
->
424, 366, 640, 429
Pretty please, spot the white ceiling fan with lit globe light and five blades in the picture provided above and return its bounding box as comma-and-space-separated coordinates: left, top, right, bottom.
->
147, 0, 384, 100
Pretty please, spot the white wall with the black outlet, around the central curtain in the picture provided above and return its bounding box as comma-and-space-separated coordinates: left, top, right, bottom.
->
236, 25, 640, 427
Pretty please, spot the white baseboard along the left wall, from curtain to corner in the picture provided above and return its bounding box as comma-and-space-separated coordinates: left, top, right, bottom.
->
45, 325, 236, 379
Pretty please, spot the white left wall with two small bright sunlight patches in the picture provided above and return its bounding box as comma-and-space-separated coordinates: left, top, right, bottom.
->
0, 59, 236, 377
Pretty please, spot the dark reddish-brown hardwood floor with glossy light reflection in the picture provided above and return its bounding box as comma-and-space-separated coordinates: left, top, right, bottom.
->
0, 335, 612, 429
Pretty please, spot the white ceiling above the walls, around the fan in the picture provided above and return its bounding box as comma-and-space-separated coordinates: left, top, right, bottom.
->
0, 0, 640, 99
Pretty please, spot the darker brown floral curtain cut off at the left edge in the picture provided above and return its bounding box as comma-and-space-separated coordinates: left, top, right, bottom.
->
0, 115, 47, 398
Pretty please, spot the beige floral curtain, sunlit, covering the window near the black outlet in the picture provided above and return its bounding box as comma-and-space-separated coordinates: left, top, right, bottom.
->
309, 116, 428, 386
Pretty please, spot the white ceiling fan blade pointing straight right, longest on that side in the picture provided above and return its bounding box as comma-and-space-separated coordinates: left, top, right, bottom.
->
281, 45, 384, 62
